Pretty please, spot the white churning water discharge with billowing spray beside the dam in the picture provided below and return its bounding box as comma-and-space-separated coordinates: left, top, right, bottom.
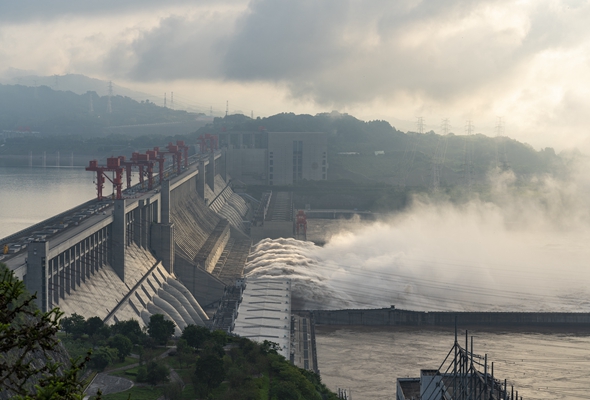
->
246, 169, 590, 312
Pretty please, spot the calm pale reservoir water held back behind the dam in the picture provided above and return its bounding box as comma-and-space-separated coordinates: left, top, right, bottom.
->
0, 167, 98, 238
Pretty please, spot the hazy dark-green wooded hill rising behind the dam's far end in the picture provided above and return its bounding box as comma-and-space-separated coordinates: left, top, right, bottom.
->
197, 112, 566, 188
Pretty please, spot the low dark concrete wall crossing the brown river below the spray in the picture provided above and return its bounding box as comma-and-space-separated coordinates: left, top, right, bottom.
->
311, 307, 590, 328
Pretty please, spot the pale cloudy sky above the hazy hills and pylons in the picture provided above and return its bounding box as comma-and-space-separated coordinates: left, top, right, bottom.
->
0, 0, 590, 153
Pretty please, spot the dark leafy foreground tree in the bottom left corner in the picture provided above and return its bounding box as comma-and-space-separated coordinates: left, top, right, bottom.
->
0, 263, 97, 400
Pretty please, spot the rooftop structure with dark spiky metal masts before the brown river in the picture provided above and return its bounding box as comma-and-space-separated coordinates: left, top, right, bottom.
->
396, 329, 522, 400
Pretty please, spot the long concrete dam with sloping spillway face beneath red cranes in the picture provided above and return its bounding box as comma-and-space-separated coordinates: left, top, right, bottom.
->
0, 151, 251, 333
